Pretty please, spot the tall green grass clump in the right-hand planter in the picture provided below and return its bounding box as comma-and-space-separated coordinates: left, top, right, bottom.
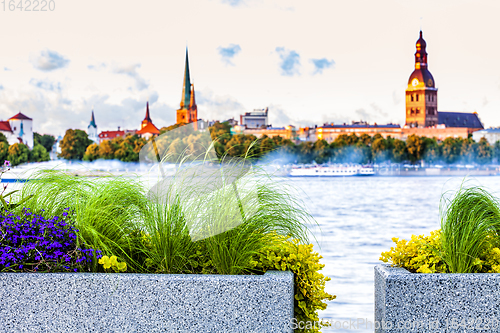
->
440, 187, 500, 273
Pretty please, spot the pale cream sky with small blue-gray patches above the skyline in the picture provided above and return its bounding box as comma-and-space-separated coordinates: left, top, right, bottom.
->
0, 0, 500, 136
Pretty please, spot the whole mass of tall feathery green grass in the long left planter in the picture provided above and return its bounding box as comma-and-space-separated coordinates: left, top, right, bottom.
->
14, 149, 314, 274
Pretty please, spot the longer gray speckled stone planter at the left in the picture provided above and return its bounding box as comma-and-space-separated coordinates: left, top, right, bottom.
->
0, 271, 294, 333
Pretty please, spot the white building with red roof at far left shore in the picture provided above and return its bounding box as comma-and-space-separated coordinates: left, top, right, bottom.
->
0, 112, 33, 149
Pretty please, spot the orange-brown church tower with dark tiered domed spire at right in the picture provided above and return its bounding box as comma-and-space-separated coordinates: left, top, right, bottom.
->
406, 31, 438, 127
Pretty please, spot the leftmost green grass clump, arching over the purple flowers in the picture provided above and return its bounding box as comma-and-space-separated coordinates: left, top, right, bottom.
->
18, 170, 147, 270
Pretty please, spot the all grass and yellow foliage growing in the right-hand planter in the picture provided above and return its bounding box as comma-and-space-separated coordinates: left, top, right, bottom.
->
380, 187, 500, 273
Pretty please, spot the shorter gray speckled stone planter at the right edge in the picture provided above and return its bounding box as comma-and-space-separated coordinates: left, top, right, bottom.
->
374, 265, 500, 333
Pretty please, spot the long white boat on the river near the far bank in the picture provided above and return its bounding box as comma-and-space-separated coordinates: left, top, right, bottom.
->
289, 164, 375, 177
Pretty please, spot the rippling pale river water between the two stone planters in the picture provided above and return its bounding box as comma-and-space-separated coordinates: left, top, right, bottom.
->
289, 177, 500, 332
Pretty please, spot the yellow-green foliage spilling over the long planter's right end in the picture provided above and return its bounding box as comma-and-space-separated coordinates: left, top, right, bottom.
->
256, 236, 336, 332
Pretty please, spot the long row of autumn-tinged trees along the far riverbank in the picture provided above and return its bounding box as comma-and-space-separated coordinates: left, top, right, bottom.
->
53, 122, 500, 164
